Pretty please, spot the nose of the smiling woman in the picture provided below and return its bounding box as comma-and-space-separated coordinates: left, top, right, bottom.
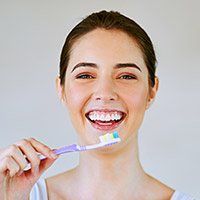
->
93, 76, 118, 101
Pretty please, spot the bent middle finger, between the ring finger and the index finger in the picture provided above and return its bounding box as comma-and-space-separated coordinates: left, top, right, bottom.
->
15, 139, 40, 171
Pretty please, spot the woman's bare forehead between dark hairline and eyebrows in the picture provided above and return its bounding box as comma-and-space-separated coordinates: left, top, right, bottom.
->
69, 29, 145, 69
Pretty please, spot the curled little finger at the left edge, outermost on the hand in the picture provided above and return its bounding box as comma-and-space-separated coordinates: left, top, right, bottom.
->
0, 156, 20, 177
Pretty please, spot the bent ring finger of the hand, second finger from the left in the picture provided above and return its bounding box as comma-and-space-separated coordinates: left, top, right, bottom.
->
4, 144, 28, 170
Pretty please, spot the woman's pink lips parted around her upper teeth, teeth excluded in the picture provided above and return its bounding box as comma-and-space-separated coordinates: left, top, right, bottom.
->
85, 109, 126, 131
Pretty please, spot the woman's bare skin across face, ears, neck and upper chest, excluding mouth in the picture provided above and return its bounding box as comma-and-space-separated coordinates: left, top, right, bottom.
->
46, 29, 174, 200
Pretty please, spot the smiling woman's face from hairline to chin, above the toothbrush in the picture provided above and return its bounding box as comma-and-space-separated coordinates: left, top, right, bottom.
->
57, 29, 156, 146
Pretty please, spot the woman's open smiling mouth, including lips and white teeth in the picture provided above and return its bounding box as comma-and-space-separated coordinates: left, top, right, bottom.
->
85, 110, 126, 131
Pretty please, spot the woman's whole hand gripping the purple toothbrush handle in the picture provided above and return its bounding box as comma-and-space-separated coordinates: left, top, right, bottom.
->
0, 138, 58, 200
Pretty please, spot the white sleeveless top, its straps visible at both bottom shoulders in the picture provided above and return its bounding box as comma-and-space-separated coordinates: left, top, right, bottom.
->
30, 178, 197, 200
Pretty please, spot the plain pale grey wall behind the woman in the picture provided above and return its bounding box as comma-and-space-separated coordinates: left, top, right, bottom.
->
0, 0, 200, 198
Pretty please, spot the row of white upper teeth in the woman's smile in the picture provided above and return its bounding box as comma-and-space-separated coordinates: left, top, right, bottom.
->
89, 112, 122, 121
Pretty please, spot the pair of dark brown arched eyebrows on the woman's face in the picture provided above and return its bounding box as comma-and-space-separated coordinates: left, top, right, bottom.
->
71, 62, 142, 73
